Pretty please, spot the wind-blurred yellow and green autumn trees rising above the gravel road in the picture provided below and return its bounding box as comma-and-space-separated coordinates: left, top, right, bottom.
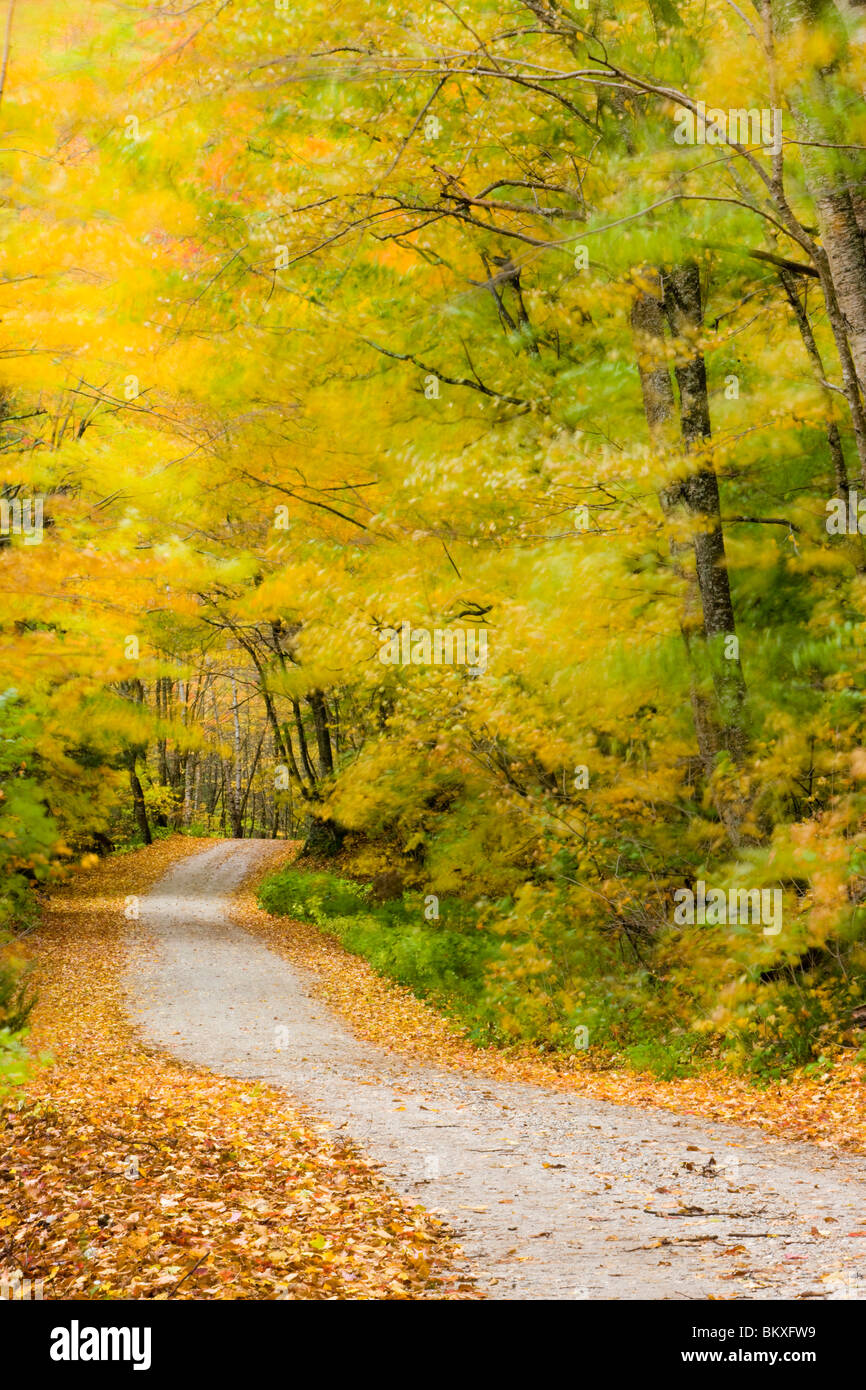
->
0, 0, 866, 1066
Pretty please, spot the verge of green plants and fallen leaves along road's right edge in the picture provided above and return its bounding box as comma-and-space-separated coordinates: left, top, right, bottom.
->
252, 847, 866, 1152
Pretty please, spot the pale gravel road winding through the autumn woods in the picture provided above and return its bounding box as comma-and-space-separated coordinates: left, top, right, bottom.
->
118, 841, 866, 1300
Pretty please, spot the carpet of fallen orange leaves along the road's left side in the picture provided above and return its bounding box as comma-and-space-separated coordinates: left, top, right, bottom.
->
0, 837, 477, 1300
